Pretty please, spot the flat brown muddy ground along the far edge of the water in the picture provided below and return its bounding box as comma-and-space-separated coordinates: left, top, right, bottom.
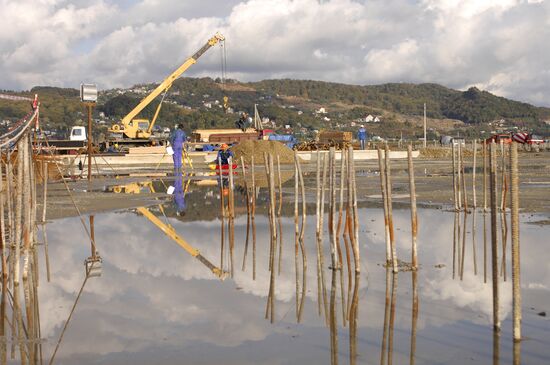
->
43, 152, 550, 220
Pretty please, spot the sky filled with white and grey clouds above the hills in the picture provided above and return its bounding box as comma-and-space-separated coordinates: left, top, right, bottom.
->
0, 0, 550, 105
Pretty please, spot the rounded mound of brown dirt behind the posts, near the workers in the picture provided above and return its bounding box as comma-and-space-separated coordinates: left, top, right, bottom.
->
232, 141, 300, 165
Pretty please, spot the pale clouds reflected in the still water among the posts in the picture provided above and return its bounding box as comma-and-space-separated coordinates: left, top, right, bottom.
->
39, 209, 550, 356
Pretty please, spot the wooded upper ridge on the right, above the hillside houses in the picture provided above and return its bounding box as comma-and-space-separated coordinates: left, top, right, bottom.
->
248, 79, 550, 123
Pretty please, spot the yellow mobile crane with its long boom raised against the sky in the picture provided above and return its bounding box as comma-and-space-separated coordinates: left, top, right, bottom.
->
109, 33, 225, 139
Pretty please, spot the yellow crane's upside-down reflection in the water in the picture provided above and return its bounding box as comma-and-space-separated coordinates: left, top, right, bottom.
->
113, 180, 227, 280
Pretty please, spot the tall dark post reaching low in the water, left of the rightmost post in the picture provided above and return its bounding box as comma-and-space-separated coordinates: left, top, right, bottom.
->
489, 143, 500, 331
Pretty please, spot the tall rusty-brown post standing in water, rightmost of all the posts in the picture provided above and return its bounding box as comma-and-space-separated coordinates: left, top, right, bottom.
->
510, 142, 521, 342
